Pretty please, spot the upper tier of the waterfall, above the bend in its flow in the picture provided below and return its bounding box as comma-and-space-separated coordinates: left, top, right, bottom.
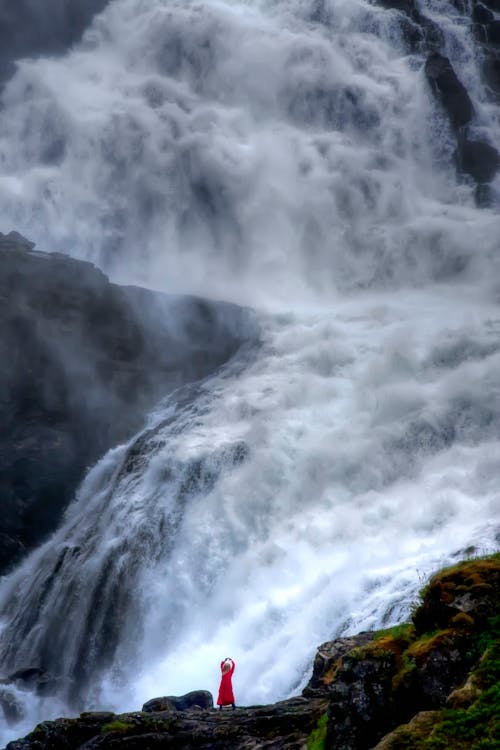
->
0, 0, 500, 303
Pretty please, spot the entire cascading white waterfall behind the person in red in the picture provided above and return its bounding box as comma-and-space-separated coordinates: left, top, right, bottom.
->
0, 0, 500, 739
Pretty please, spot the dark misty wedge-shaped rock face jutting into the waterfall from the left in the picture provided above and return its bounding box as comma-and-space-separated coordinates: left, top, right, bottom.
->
0, 233, 255, 574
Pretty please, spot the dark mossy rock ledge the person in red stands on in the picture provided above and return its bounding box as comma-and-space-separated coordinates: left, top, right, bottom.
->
2, 554, 500, 750
